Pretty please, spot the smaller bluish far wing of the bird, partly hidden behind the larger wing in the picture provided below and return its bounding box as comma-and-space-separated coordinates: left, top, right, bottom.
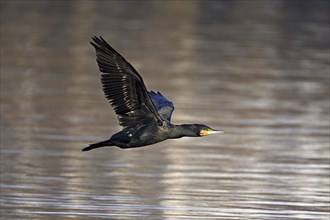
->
148, 91, 174, 122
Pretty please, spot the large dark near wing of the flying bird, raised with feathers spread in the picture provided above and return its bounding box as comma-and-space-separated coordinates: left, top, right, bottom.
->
91, 37, 163, 127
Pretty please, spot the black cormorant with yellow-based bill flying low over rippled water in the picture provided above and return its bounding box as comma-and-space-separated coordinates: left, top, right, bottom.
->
82, 37, 223, 151
